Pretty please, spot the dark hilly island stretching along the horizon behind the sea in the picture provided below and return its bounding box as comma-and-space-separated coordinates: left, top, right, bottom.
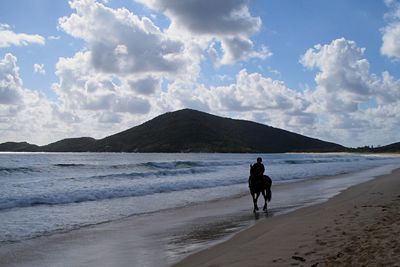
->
0, 109, 400, 153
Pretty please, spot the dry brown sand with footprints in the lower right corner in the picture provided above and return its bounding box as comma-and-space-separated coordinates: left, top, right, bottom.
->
176, 169, 400, 267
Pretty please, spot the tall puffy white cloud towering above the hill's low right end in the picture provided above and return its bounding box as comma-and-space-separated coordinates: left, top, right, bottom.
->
300, 38, 400, 144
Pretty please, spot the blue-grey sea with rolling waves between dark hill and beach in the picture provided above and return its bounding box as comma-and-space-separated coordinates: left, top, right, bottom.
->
0, 153, 400, 244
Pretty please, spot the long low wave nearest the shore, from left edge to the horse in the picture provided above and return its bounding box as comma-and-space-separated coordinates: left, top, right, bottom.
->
0, 178, 247, 213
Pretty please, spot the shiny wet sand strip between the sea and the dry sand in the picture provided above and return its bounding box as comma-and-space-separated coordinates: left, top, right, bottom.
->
0, 166, 393, 267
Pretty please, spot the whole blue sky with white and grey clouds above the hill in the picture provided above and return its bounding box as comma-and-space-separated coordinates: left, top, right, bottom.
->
0, 0, 400, 147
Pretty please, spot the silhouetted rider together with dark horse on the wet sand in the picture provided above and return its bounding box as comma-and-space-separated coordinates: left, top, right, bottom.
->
249, 157, 272, 212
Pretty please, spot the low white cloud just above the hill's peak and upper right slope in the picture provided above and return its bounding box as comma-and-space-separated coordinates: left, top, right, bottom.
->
162, 69, 316, 131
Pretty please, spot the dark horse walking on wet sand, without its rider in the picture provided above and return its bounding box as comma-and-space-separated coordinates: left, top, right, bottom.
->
249, 168, 272, 213
